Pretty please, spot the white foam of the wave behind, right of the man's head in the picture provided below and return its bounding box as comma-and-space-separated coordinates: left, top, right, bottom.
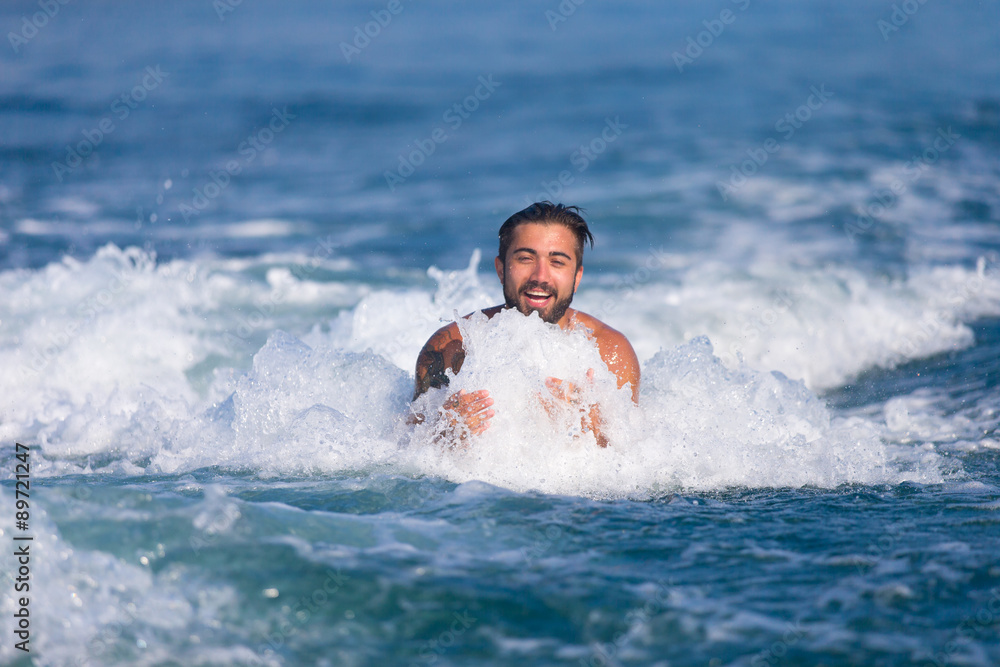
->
579, 258, 1000, 389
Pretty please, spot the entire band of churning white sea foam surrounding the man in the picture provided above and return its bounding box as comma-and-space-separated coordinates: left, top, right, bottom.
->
0, 246, 1000, 496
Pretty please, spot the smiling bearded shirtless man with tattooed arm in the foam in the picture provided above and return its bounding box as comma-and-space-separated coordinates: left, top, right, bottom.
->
413, 201, 639, 447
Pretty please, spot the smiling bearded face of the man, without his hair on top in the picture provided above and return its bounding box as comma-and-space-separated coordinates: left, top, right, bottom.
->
494, 222, 583, 326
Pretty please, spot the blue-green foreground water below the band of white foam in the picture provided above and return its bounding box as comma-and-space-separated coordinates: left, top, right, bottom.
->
13, 470, 997, 664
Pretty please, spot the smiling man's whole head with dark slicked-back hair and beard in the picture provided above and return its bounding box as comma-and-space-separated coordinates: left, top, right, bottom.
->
494, 201, 594, 324
